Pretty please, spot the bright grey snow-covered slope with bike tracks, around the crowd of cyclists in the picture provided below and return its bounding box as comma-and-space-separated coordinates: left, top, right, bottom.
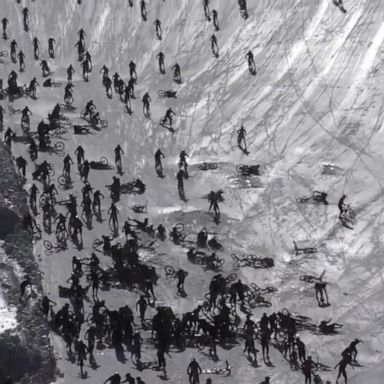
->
0, 0, 384, 384
